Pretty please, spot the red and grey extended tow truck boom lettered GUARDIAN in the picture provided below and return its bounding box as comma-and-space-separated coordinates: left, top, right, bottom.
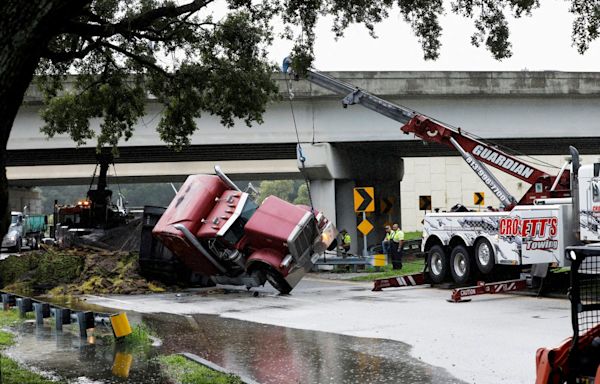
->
300, 67, 570, 210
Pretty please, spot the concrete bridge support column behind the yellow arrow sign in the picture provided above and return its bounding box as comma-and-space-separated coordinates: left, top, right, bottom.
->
298, 143, 403, 254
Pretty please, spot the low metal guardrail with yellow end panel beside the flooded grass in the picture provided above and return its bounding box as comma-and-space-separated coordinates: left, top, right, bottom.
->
0, 291, 131, 338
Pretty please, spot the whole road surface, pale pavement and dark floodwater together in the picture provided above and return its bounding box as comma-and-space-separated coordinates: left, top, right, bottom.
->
1, 278, 570, 384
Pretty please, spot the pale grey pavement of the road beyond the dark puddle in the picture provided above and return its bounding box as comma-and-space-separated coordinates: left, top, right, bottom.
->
89, 278, 572, 384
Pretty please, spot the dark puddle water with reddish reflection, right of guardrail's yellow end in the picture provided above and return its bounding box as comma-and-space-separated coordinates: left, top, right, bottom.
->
143, 314, 461, 384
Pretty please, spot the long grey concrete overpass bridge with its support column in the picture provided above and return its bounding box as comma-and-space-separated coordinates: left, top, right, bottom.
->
7, 71, 600, 252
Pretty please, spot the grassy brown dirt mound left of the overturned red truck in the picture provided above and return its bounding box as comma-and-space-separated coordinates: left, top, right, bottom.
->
0, 247, 165, 295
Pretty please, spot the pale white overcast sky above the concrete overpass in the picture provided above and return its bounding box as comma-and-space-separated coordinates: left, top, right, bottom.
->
269, 0, 600, 72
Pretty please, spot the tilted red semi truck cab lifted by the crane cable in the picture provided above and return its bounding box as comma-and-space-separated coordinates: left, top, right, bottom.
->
152, 167, 337, 293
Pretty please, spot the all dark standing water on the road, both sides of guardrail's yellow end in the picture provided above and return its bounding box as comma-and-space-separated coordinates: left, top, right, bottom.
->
2, 300, 463, 384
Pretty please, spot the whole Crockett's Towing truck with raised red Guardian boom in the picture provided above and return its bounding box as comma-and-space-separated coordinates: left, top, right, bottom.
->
283, 62, 600, 285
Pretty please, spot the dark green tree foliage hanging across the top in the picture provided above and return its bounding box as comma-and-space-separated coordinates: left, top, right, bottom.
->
23, 0, 600, 156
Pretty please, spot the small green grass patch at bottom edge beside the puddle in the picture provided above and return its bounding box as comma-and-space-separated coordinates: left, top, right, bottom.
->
159, 355, 243, 384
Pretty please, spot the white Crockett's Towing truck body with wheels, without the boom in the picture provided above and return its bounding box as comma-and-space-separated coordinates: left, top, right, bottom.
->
422, 163, 600, 280
